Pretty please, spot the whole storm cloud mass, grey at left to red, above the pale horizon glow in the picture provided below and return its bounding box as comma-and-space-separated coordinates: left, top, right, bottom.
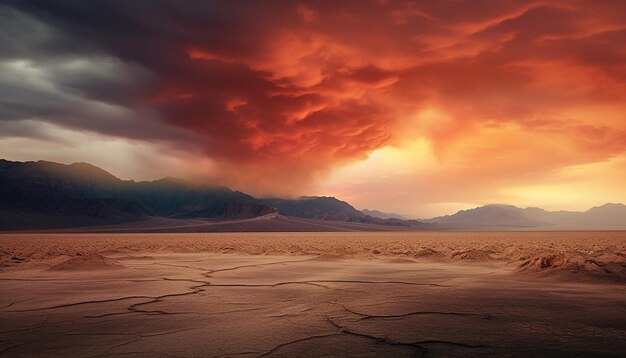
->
0, 0, 626, 193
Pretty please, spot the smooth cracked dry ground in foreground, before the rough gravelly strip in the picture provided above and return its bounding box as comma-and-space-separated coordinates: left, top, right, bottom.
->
0, 234, 626, 357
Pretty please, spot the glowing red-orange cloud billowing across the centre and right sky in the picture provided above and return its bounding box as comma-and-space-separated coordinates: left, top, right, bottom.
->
7, 0, 626, 191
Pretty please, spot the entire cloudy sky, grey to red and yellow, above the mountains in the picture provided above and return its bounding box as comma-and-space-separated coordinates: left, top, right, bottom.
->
0, 0, 626, 218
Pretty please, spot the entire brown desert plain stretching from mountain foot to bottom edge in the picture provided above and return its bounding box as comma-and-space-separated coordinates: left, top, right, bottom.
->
0, 231, 626, 357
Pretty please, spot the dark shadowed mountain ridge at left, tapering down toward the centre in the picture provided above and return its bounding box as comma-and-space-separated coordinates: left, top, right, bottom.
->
0, 160, 419, 230
